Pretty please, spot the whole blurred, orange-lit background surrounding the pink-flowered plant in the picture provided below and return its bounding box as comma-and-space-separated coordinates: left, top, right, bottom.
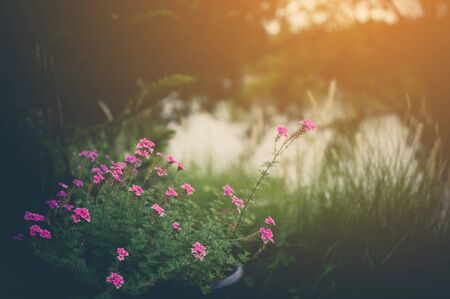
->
0, 0, 450, 298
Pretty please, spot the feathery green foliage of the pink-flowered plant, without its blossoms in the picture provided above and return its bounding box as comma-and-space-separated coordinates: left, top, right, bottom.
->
28, 135, 284, 296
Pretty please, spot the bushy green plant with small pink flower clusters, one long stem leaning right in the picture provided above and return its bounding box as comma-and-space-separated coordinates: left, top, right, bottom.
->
14, 121, 314, 295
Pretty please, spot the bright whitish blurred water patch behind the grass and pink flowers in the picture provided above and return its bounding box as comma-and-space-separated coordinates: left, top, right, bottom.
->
169, 92, 422, 188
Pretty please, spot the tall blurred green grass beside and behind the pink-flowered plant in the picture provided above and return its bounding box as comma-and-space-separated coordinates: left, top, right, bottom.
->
171, 87, 450, 298
